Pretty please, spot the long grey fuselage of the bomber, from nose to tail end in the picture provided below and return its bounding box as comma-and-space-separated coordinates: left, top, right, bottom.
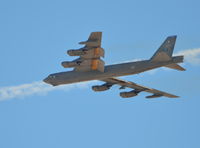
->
43, 56, 183, 86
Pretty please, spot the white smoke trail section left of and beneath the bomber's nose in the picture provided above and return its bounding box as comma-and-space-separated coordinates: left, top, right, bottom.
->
0, 81, 95, 101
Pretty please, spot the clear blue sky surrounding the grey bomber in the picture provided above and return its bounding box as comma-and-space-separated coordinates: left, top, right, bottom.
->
0, 0, 200, 148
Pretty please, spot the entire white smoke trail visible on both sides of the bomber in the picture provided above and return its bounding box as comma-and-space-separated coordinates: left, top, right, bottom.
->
0, 48, 200, 101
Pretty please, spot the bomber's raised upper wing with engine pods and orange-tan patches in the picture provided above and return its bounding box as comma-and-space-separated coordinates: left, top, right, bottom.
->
62, 32, 105, 72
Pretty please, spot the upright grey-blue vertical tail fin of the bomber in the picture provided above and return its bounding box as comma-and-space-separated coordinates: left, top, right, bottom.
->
150, 36, 176, 62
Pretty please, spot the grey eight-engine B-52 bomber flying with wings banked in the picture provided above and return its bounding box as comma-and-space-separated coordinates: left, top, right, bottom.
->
43, 32, 185, 98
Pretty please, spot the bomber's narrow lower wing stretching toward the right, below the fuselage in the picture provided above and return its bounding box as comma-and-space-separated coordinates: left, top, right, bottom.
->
102, 78, 178, 98
